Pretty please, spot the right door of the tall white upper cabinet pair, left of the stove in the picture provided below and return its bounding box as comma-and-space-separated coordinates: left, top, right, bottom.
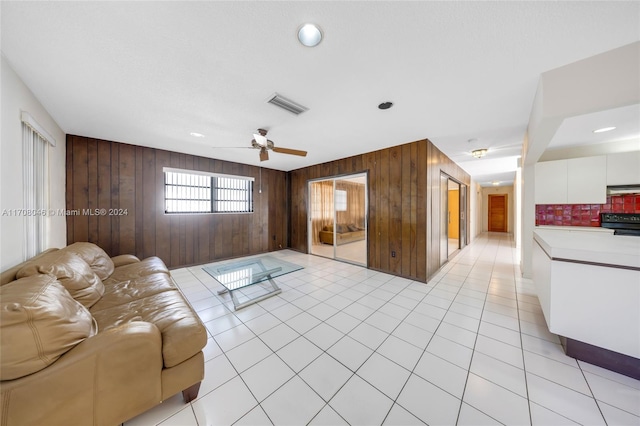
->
567, 155, 607, 204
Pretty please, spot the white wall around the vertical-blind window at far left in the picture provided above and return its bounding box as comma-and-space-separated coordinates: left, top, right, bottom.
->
0, 56, 67, 270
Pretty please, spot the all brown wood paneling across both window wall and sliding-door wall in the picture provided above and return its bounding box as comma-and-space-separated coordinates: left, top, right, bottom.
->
66, 135, 470, 282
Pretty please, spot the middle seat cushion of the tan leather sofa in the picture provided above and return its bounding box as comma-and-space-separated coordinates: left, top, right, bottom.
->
90, 273, 176, 313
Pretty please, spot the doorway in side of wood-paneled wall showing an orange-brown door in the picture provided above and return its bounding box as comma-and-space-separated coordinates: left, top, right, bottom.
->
440, 173, 467, 266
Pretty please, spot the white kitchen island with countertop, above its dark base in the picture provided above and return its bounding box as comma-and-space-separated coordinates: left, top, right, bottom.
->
533, 229, 640, 358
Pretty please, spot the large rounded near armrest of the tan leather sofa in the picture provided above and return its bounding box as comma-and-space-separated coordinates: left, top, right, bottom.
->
0, 322, 162, 425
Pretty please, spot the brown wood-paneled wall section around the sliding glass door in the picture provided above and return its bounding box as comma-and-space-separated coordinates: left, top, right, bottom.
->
289, 140, 470, 281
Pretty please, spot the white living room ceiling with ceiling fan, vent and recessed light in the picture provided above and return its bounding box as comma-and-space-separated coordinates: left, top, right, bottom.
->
0, 1, 640, 185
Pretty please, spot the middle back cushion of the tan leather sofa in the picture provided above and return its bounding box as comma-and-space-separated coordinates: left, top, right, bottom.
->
16, 250, 104, 308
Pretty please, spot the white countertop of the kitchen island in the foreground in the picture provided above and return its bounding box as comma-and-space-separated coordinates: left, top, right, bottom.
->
533, 228, 640, 270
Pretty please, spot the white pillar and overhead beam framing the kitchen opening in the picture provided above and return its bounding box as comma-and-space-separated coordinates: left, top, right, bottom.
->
521, 41, 640, 278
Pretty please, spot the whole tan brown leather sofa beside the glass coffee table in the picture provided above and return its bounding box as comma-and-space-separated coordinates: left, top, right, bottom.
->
0, 243, 207, 426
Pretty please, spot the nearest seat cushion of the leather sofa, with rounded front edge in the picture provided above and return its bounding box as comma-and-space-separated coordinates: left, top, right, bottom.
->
93, 290, 207, 367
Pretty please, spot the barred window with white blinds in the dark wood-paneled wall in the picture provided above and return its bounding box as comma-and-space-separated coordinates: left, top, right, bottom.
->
164, 168, 253, 214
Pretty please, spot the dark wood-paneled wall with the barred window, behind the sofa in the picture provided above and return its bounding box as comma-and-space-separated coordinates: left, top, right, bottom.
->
66, 135, 289, 267
